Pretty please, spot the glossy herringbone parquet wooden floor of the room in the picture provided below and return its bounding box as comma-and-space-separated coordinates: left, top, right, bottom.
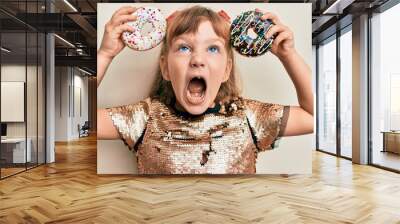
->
0, 137, 400, 224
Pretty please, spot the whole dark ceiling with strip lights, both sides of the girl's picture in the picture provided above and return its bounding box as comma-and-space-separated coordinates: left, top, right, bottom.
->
0, 0, 394, 74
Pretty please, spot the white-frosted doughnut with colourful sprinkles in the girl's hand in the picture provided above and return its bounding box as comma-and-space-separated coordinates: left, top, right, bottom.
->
122, 7, 167, 51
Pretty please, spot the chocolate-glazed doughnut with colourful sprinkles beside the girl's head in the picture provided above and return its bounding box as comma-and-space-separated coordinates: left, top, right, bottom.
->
231, 11, 273, 57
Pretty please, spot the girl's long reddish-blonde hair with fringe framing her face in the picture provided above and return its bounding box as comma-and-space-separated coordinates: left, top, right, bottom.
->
150, 6, 241, 104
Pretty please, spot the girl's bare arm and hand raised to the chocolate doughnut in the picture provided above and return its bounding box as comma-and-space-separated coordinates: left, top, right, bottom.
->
262, 9, 314, 136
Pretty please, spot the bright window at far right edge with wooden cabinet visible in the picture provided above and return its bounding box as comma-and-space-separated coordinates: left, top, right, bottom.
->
370, 4, 400, 171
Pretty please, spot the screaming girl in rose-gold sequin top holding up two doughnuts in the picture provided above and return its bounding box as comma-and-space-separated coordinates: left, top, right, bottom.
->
97, 6, 313, 174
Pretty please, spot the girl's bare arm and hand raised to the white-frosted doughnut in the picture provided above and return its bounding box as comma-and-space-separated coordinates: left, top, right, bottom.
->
97, 6, 136, 139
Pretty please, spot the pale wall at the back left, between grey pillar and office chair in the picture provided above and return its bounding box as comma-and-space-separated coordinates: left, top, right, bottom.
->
55, 67, 88, 141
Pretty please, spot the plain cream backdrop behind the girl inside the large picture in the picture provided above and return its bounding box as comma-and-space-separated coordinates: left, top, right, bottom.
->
97, 3, 315, 174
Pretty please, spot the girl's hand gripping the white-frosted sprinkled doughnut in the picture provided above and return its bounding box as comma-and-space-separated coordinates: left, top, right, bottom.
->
98, 6, 136, 59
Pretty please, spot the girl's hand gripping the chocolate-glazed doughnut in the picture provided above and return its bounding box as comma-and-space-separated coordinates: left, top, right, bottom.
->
256, 9, 295, 59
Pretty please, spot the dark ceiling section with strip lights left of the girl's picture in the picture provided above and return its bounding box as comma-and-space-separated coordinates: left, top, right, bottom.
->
0, 0, 97, 75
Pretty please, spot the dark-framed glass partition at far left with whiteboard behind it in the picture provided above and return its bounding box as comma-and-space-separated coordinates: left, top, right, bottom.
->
0, 1, 46, 178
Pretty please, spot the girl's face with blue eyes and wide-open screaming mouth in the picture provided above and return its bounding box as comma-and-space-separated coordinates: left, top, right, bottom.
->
161, 20, 232, 115
